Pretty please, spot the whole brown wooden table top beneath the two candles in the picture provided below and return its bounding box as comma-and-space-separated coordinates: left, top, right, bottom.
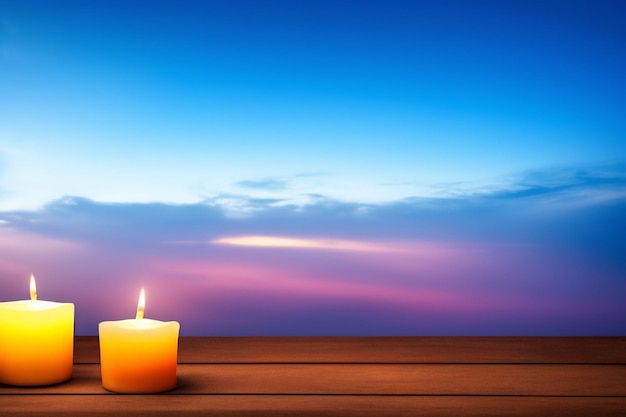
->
0, 337, 626, 417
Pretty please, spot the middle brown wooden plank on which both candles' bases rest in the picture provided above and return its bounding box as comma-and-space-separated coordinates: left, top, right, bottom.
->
0, 364, 626, 396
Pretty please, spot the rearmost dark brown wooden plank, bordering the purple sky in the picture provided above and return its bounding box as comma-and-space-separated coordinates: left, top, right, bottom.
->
74, 336, 626, 364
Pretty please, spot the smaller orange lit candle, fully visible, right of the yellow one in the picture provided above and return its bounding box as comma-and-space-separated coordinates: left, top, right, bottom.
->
98, 288, 180, 394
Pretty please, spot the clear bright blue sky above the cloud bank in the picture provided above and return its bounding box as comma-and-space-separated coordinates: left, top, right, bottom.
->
0, 1, 626, 209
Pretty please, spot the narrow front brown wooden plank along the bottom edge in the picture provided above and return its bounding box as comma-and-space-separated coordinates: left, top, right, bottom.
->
0, 395, 626, 417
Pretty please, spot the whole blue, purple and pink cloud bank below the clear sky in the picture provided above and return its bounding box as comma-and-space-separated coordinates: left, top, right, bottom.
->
0, 162, 626, 334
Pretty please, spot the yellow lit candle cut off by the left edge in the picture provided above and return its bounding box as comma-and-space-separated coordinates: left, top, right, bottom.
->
0, 275, 74, 386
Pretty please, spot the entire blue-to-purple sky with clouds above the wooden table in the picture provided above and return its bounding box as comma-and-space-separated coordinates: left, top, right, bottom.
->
0, 0, 626, 336
